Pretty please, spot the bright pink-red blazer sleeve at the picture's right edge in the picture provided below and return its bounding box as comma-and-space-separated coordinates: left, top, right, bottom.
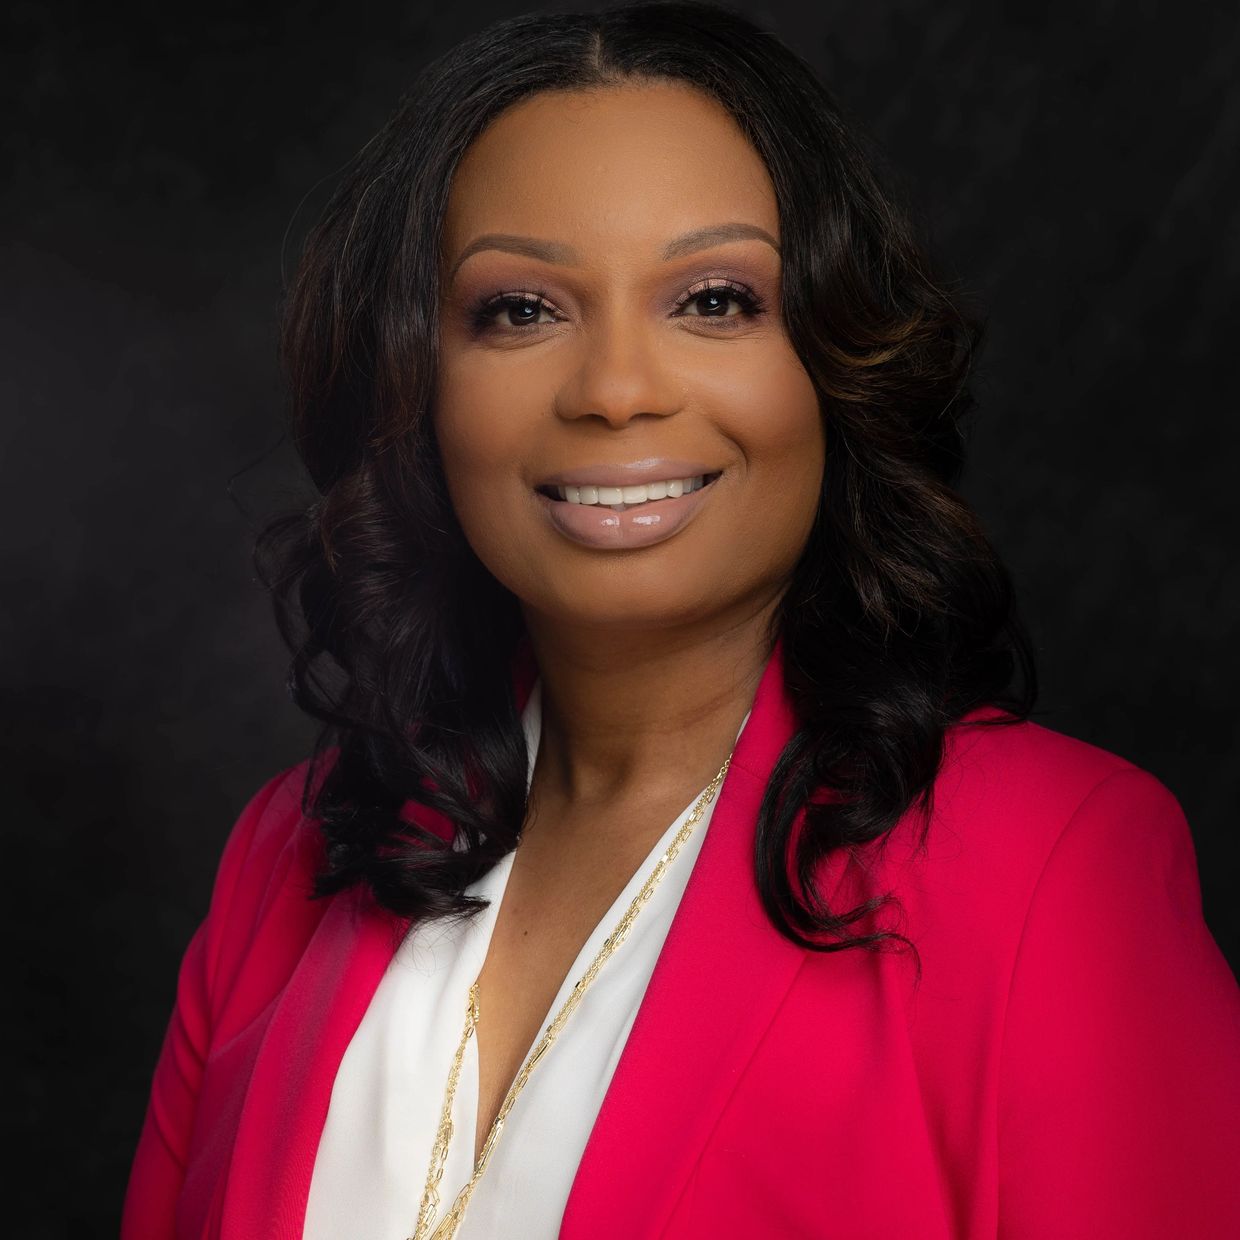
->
998, 766, 1240, 1240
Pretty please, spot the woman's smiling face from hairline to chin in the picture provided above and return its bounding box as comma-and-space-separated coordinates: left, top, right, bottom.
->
435, 84, 825, 630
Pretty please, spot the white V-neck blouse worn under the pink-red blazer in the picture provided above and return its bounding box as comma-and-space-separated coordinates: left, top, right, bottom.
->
303, 680, 751, 1240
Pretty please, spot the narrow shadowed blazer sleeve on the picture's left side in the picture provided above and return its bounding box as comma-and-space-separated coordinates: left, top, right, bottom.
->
120, 768, 293, 1240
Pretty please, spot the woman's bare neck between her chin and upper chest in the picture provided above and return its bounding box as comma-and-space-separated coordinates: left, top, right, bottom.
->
526, 600, 777, 811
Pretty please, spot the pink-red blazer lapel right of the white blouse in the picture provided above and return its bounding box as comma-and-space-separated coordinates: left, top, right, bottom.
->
559, 642, 844, 1240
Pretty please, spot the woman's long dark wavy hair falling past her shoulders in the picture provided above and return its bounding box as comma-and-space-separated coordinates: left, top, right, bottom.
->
254, 2, 1037, 976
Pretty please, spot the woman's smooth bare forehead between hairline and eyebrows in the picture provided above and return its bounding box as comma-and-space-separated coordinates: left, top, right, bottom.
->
444, 83, 779, 259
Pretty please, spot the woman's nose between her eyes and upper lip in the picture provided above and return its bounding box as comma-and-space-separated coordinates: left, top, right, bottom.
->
557, 308, 681, 429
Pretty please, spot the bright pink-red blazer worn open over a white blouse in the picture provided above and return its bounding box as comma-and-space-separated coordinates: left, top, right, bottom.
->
122, 646, 1240, 1240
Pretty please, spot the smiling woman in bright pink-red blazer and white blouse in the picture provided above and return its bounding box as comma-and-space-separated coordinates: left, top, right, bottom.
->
124, 4, 1240, 1240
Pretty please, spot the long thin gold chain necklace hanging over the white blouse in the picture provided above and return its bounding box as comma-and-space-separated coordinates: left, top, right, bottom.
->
409, 754, 732, 1240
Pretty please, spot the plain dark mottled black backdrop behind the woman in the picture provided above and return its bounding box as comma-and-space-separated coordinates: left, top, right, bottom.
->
0, 0, 1240, 1238
